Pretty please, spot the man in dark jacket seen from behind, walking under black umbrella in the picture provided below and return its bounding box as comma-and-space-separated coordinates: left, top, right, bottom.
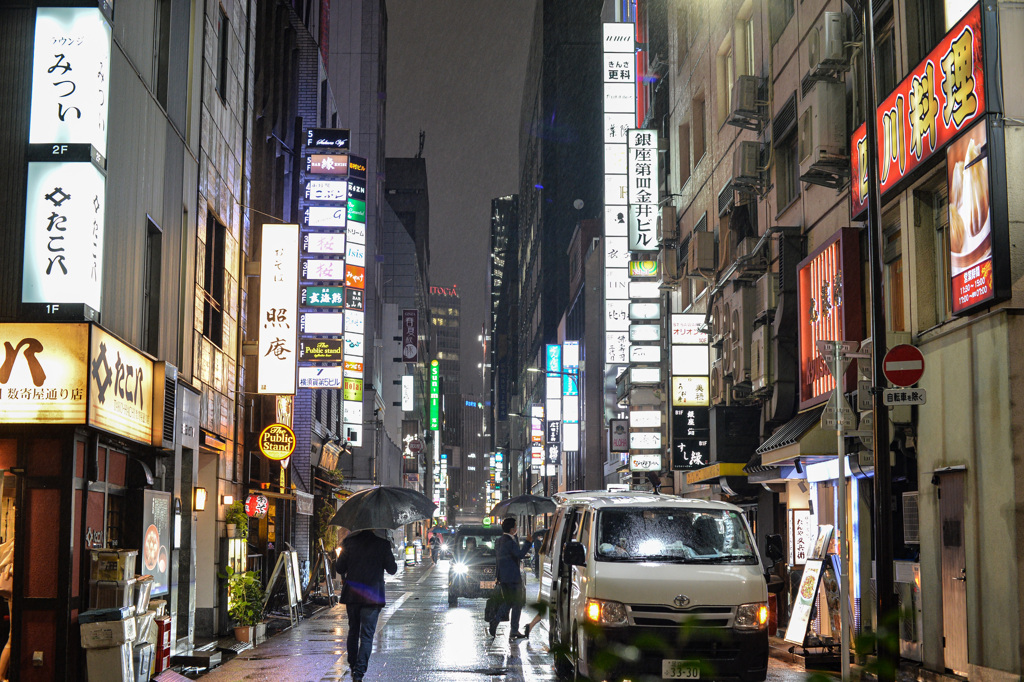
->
335, 530, 398, 682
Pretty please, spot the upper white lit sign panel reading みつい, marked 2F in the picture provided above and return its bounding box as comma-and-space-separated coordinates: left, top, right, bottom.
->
29, 7, 111, 155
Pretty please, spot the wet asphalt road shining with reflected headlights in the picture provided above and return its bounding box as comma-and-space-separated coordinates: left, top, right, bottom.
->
200, 561, 806, 682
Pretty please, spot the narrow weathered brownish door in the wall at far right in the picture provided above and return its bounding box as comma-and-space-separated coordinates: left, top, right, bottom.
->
938, 471, 968, 677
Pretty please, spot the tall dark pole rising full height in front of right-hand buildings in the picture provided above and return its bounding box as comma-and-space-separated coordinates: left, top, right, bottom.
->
859, 0, 899, 682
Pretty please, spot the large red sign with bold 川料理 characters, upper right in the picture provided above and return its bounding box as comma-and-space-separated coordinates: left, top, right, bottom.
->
872, 3, 985, 196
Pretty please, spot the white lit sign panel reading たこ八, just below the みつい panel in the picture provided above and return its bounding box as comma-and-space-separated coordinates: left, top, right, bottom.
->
22, 160, 106, 313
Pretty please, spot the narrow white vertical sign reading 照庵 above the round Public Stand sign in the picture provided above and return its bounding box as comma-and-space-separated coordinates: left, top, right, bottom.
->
257, 224, 299, 395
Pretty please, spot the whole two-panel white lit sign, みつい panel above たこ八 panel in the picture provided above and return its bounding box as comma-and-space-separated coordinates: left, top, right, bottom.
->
22, 7, 111, 317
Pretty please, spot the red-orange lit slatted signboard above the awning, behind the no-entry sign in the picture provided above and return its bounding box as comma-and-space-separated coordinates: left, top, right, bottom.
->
797, 227, 863, 410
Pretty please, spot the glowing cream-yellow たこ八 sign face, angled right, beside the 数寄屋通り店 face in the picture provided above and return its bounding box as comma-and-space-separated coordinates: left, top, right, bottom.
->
89, 326, 154, 443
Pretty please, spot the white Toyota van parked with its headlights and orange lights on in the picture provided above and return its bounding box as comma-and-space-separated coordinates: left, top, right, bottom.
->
541, 492, 768, 682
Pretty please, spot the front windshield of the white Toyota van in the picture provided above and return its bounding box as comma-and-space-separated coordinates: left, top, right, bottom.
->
595, 507, 758, 564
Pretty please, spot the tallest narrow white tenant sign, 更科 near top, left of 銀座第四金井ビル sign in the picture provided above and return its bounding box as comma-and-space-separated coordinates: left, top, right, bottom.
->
601, 23, 636, 373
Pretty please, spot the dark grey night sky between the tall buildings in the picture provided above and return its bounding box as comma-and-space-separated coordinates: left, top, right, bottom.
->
387, 0, 535, 394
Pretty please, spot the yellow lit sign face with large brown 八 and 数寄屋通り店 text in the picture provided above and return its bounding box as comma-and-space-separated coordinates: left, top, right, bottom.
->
0, 324, 89, 424
